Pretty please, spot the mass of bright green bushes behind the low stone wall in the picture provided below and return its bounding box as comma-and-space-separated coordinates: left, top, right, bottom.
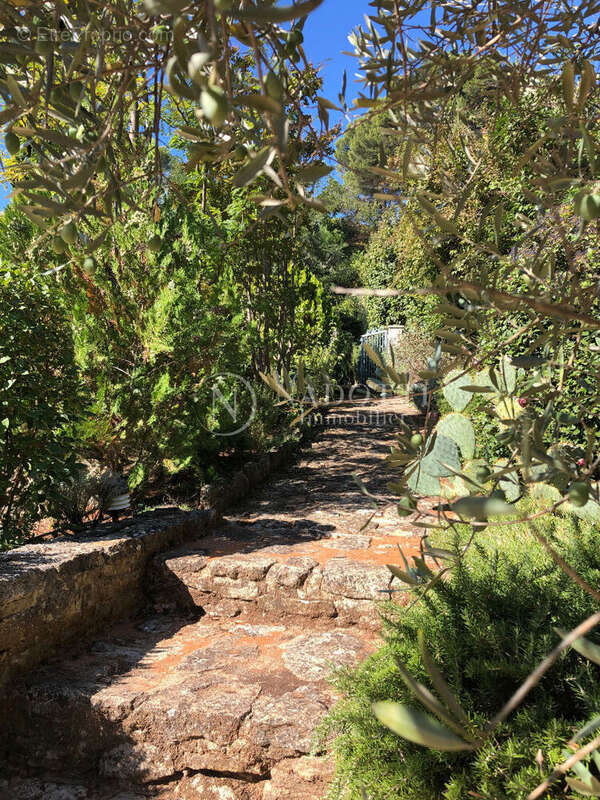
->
0, 144, 364, 545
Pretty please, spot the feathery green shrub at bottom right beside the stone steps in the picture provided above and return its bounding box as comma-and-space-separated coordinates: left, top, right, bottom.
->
322, 517, 600, 800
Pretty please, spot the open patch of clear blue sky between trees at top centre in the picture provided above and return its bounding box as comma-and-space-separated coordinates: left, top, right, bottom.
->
0, 0, 369, 209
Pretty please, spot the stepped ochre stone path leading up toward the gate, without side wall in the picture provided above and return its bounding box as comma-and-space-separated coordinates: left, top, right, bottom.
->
0, 399, 417, 800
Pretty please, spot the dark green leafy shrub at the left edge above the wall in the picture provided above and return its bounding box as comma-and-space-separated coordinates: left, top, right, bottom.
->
0, 266, 82, 549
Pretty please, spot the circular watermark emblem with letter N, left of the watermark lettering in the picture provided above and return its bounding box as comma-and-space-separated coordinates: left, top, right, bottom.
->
196, 372, 257, 436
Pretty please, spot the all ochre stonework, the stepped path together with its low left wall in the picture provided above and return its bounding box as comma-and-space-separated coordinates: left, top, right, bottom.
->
0, 399, 419, 800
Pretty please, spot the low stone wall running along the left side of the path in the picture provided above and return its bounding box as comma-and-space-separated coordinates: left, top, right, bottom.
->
0, 446, 294, 686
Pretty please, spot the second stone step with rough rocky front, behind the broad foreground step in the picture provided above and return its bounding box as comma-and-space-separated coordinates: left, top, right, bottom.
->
150, 523, 402, 628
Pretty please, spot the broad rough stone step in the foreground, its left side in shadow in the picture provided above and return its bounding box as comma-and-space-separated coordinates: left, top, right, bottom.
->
3, 612, 373, 800
